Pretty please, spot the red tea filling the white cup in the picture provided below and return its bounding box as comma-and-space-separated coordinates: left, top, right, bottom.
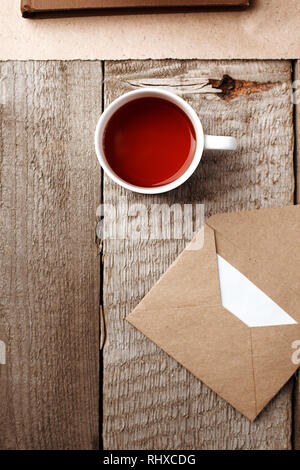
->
103, 97, 196, 188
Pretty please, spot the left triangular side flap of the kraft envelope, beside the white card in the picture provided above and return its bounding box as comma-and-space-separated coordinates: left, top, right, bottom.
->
131, 226, 221, 309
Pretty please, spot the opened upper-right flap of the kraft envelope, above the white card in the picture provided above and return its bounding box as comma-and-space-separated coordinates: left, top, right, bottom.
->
207, 205, 300, 295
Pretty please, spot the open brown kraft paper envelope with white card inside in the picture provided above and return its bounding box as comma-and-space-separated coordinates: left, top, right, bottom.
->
127, 205, 300, 420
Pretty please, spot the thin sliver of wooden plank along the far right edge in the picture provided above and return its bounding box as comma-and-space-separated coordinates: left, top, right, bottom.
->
293, 61, 300, 450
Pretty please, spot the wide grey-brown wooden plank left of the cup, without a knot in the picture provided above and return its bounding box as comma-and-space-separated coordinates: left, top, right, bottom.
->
0, 61, 102, 449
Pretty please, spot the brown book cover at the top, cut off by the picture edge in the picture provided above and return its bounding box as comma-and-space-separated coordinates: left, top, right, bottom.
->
21, 0, 249, 16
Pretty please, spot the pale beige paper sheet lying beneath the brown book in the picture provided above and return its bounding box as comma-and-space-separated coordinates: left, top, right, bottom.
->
0, 0, 300, 60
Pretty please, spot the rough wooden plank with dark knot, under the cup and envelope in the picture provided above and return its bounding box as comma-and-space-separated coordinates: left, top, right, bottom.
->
103, 60, 294, 450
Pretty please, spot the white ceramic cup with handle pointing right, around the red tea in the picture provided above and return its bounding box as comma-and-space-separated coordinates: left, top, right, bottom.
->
95, 88, 237, 194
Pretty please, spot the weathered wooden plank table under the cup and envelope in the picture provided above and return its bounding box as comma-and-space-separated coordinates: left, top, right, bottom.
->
0, 60, 300, 450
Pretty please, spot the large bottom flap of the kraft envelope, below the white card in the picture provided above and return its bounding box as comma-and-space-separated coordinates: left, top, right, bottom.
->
126, 304, 257, 420
